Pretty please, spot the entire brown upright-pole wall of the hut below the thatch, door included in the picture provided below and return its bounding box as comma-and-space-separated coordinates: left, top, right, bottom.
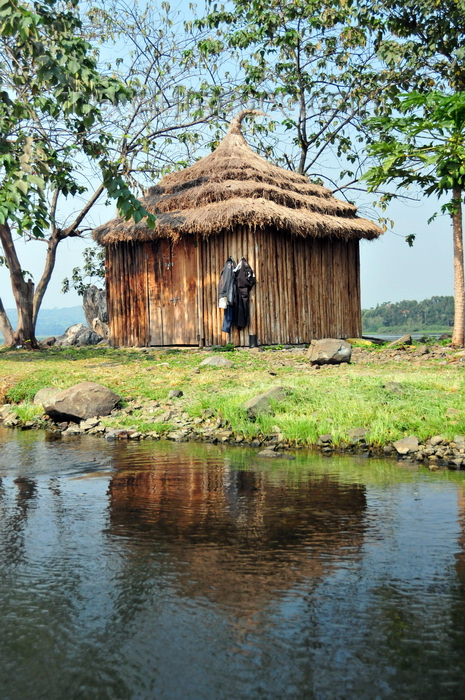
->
107, 227, 362, 346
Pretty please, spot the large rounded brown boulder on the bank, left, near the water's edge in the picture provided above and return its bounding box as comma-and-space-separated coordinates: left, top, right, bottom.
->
44, 382, 121, 422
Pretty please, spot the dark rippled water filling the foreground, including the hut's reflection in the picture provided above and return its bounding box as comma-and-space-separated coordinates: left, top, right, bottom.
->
0, 429, 465, 700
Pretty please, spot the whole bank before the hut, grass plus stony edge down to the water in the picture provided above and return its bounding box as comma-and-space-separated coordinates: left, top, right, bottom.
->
0, 344, 465, 470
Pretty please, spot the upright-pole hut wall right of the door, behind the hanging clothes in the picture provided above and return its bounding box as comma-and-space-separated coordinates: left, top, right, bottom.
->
201, 227, 362, 346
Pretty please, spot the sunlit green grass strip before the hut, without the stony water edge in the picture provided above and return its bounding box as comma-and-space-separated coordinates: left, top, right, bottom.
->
0, 347, 465, 446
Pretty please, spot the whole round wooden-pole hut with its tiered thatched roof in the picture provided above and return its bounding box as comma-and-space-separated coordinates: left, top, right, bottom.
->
94, 111, 382, 346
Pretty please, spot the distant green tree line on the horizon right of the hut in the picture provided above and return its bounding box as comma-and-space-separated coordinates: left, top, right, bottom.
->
362, 296, 454, 333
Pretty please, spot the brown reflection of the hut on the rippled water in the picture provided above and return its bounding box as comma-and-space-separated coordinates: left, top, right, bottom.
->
109, 453, 366, 612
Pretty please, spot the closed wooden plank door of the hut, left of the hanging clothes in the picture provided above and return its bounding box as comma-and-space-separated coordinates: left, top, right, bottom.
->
147, 236, 198, 345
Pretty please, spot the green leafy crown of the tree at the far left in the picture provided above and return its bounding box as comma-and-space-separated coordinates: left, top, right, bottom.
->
0, 0, 134, 237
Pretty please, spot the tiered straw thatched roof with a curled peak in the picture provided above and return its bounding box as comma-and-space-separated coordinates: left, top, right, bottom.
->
93, 110, 382, 245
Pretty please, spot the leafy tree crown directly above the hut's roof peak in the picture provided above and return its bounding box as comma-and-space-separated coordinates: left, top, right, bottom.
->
202, 0, 396, 186
